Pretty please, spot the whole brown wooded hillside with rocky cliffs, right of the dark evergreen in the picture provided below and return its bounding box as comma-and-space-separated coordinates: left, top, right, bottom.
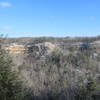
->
2, 37, 100, 100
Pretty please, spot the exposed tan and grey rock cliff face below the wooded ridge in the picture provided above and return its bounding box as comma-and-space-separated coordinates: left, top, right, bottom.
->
5, 42, 56, 55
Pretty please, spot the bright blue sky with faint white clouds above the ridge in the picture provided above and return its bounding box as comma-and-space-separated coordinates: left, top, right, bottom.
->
0, 0, 100, 37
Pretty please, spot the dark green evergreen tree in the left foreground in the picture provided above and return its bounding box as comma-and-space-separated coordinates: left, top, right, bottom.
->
0, 41, 22, 100
